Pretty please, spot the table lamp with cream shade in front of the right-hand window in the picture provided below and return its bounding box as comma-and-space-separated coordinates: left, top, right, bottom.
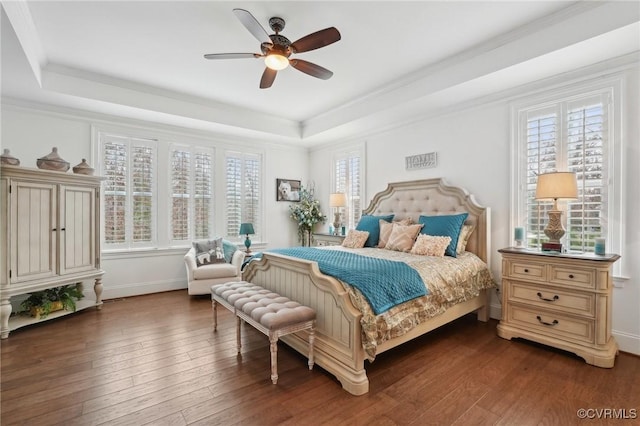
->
536, 172, 578, 251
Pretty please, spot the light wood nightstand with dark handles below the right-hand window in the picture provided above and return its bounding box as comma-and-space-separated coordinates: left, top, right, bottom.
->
498, 248, 620, 368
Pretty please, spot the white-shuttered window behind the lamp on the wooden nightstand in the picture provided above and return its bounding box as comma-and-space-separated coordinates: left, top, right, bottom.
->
513, 78, 621, 260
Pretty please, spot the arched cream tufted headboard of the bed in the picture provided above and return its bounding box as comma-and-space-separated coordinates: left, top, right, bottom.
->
363, 178, 491, 264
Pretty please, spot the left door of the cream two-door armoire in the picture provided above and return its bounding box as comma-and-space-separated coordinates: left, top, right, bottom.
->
10, 180, 58, 283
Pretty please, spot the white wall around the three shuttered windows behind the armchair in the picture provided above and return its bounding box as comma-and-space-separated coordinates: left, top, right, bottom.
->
1, 104, 308, 299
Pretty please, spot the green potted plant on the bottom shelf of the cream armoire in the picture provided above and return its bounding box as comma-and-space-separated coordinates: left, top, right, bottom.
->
20, 284, 84, 318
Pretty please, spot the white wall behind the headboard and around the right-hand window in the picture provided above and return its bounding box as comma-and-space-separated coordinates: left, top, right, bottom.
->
310, 67, 640, 354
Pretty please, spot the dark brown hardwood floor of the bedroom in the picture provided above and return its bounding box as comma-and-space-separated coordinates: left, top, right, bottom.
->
0, 290, 640, 426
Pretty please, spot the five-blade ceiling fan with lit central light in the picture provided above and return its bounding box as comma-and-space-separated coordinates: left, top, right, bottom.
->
204, 9, 340, 89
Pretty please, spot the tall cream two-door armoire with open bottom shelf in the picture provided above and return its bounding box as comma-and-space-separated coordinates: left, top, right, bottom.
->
0, 165, 104, 339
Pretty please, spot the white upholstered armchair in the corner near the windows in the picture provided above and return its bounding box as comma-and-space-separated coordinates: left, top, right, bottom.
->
184, 247, 244, 294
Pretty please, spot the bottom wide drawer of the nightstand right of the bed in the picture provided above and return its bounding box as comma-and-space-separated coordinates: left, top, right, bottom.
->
507, 305, 595, 343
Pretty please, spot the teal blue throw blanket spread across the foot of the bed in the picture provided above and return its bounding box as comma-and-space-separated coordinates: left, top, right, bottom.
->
248, 247, 427, 315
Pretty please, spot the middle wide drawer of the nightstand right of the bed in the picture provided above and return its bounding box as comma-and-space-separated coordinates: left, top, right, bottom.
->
509, 282, 596, 317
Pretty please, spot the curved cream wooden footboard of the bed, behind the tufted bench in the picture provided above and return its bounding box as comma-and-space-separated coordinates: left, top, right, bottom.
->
243, 253, 369, 395
